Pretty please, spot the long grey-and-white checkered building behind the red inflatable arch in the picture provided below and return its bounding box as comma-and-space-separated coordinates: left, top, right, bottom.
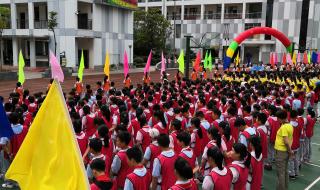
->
138, 0, 320, 63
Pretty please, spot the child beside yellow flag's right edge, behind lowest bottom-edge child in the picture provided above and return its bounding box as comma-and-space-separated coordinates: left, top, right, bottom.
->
87, 138, 105, 180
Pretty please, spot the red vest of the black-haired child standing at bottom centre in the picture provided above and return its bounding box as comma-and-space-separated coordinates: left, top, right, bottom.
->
158, 154, 177, 190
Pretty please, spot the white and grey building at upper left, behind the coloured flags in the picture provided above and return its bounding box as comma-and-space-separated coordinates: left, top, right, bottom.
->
0, 0, 133, 68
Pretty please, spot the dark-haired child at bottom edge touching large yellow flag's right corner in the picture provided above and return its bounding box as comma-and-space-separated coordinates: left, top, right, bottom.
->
90, 159, 112, 190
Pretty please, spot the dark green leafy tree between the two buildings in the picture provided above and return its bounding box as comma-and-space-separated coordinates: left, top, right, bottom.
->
133, 10, 171, 56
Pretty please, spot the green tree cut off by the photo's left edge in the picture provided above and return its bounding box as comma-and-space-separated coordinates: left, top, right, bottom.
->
0, 6, 10, 71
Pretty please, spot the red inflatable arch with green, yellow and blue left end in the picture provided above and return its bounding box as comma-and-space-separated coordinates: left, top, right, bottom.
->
223, 27, 292, 70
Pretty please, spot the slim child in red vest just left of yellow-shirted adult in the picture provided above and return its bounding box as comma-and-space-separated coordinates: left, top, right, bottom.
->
256, 112, 268, 168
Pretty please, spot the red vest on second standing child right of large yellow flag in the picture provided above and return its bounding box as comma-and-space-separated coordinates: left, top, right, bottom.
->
117, 151, 133, 188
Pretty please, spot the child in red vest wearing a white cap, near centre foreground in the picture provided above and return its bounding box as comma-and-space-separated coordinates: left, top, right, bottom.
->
143, 128, 161, 172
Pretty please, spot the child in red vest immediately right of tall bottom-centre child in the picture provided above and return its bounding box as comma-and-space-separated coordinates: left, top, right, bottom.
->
177, 131, 198, 170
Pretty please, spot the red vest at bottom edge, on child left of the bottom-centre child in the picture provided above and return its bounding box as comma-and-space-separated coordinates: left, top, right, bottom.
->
127, 167, 151, 190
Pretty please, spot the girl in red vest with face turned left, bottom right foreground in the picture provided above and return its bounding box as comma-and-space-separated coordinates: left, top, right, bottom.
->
228, 143, 251, 190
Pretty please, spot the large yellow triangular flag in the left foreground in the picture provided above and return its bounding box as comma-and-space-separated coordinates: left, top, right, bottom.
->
6, 81, 89, 190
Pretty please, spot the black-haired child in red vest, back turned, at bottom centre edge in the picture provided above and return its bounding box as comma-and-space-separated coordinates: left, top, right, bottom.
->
151, 134, 177, 190
